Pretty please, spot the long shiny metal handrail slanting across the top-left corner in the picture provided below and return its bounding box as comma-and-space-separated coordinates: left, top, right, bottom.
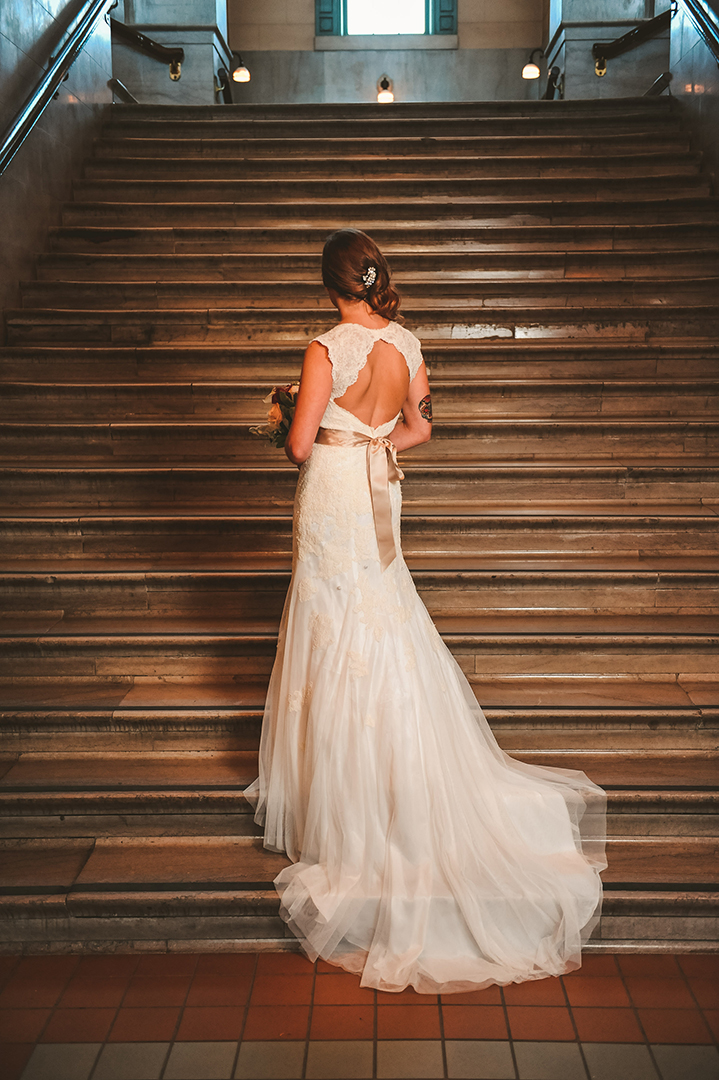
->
0, 0, 117, 176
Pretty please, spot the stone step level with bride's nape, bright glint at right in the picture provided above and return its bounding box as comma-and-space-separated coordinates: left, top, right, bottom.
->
5, 304, 719, 351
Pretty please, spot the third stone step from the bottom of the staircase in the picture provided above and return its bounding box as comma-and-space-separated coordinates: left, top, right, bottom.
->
0, 682, 719, 757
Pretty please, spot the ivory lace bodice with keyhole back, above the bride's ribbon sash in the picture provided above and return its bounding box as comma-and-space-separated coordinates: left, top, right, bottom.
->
314, 323, 422, 435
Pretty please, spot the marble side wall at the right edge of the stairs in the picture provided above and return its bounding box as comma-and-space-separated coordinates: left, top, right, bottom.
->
670, 4, 719, 193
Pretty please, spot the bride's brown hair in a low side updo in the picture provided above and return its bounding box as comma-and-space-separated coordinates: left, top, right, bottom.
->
322, 229, 402, 320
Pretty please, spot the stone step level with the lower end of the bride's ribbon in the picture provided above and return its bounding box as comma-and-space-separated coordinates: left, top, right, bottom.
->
0, 502, 719, 569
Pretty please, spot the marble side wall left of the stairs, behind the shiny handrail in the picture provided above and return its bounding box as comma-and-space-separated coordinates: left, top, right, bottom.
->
0, 0, 112, 319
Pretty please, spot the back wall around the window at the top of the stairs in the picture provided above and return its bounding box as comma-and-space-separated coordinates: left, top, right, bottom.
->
228, 0, 546, 103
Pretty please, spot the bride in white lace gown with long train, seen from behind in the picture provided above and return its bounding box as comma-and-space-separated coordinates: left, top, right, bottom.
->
241, 229, 607, 994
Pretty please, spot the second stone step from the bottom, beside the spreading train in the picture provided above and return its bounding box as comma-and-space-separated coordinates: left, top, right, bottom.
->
0, 752, 719, 838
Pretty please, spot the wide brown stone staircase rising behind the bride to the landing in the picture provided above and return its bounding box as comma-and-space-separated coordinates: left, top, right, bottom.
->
0, 98, 719, 951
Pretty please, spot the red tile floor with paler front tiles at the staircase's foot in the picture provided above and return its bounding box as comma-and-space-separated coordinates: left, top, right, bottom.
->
0, 953, 719, 1080
